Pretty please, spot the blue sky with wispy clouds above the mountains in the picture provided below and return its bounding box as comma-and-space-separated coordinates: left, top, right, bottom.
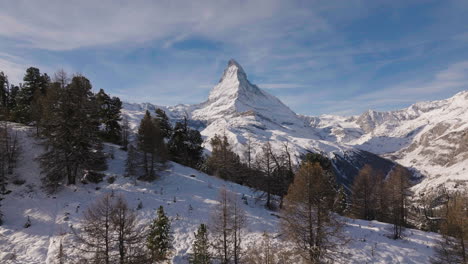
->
0, 0, 468, 115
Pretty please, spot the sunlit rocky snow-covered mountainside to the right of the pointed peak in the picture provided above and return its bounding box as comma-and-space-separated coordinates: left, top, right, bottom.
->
303, 91, 468, 192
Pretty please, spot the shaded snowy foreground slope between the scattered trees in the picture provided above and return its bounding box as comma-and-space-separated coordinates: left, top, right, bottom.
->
0, 125, 439, 264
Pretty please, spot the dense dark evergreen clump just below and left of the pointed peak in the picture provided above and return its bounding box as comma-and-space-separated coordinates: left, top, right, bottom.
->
168, 119, 203, 168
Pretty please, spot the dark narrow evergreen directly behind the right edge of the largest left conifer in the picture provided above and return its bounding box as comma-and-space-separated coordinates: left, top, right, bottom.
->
96, 89, 122, 144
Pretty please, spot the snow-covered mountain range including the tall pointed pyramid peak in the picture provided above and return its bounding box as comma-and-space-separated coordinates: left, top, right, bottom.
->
124, 60, 468, 195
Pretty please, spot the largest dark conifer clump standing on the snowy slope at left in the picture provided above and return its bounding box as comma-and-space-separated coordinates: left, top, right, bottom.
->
39, 72, 105, 191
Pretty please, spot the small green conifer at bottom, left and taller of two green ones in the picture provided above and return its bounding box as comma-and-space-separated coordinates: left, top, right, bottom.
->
146, 206, 172, 261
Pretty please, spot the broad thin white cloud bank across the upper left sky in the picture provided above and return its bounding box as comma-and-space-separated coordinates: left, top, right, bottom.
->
0, 0, 326, 50
